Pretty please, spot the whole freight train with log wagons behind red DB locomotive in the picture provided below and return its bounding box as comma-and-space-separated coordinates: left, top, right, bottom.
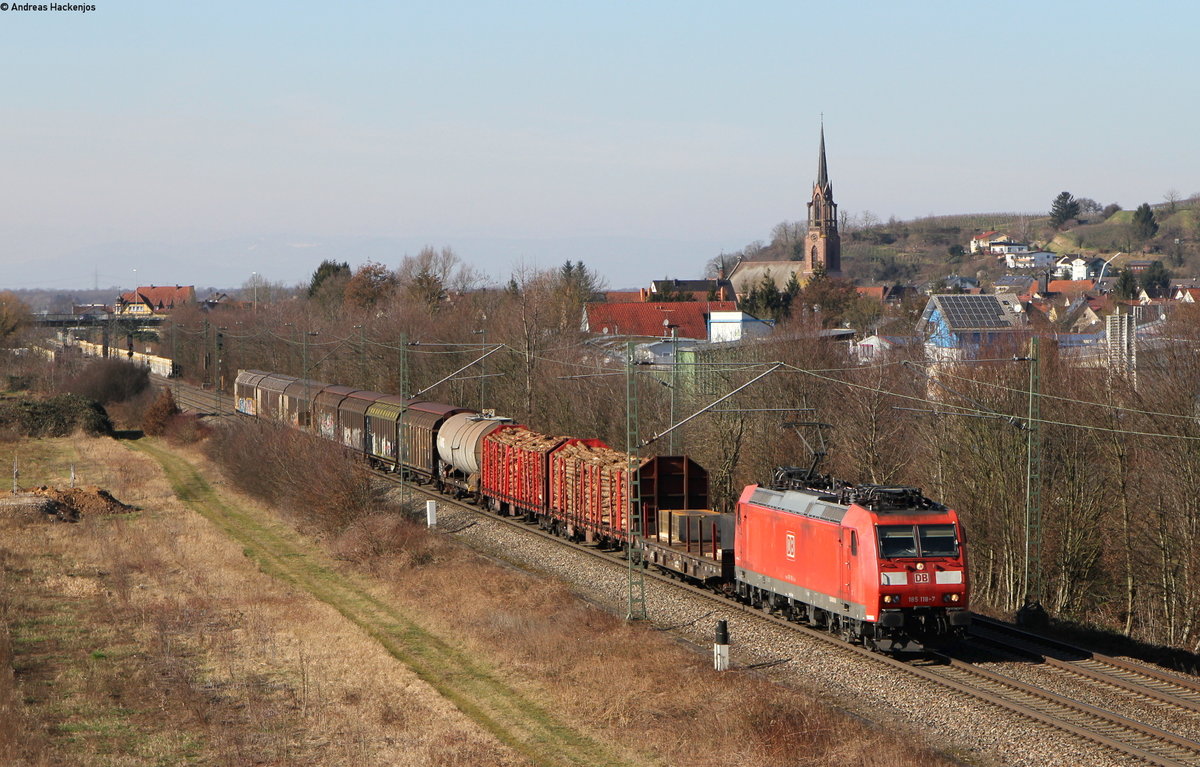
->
234, 370, 971, 649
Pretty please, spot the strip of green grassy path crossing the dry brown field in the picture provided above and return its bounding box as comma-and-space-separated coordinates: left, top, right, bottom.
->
132, 439, 628, 767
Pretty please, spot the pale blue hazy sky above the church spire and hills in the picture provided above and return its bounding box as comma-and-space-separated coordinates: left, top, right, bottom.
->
0, 0, 1200, 290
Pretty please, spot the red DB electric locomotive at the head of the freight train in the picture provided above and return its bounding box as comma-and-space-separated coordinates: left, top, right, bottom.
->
734, 468, 971, 648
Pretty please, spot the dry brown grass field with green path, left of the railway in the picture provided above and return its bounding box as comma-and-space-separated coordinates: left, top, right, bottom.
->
0, 438, 952, 767
